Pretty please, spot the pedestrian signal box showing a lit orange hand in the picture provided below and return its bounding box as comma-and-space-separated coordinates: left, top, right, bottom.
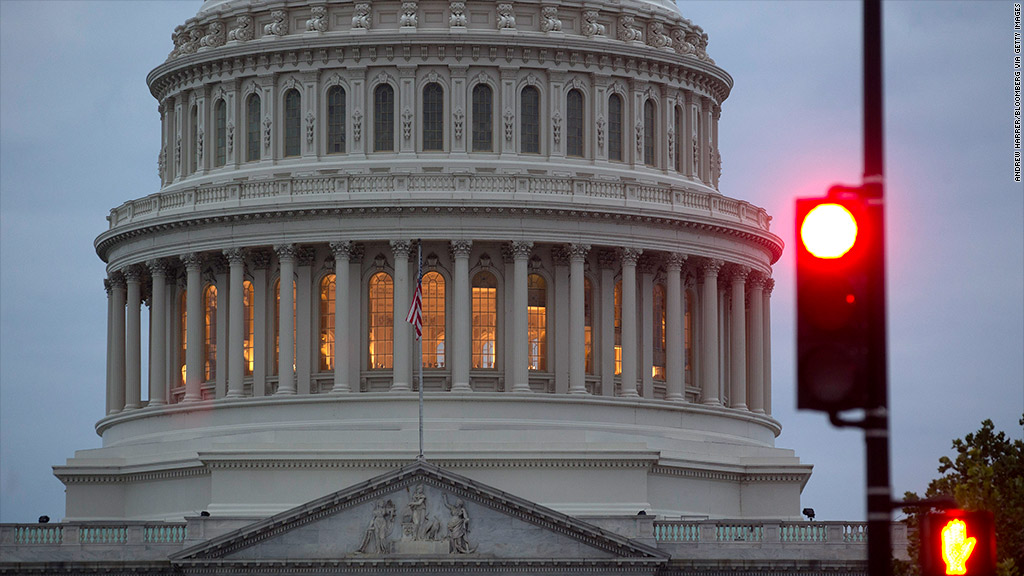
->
920, 510, 996, 576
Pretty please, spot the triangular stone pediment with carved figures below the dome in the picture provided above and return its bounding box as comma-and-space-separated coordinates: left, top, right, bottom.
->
171, 460, 668, 572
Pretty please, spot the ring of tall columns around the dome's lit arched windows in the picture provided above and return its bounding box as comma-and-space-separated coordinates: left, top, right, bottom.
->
105, 240, 773, 414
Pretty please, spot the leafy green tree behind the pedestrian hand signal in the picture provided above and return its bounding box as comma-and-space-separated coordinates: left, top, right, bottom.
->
894, 416, 1024, 576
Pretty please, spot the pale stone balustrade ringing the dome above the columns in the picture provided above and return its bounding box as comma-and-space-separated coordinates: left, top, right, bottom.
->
108, 173, 771, 232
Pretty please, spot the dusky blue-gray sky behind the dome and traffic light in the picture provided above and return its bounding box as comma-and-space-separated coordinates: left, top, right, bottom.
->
0, 0, 1024, 522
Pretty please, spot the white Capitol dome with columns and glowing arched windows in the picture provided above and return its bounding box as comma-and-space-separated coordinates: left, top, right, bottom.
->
64, 0, 810, 521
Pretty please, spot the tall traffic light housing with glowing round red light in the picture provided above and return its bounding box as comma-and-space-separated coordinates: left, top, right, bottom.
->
797, 187, 886, 413
